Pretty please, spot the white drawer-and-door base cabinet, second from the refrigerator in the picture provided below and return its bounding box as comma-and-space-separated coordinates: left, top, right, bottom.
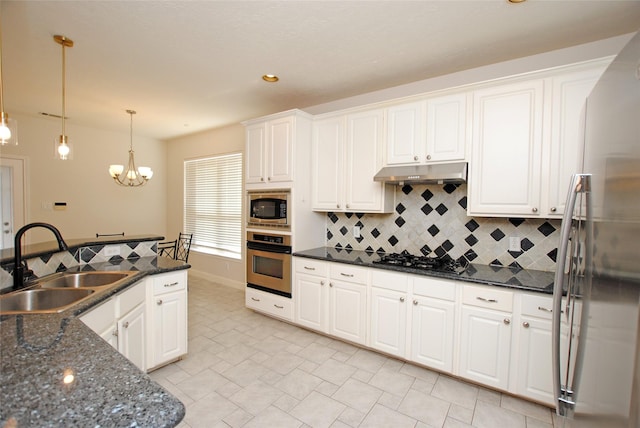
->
458, 285, 513, 390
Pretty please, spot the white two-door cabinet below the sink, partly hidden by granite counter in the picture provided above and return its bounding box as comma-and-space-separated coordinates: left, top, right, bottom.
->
80, 281, 147, 370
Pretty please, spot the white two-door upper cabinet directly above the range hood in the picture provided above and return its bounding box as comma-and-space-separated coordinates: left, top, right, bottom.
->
385, 93, 467, 165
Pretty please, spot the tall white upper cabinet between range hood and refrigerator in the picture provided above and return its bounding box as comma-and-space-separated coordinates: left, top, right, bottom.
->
468, 60, 608, 218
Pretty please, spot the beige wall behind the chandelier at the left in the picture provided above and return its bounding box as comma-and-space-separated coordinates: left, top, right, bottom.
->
0, 114, 167, 242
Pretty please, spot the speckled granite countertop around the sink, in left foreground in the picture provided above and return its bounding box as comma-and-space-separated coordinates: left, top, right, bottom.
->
0, 256, 191, 427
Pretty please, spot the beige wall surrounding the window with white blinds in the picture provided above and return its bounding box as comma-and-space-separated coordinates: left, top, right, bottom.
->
167, 124, 245, 288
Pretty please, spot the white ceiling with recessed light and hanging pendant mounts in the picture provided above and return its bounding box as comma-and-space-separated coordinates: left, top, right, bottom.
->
0, 0, 640, 139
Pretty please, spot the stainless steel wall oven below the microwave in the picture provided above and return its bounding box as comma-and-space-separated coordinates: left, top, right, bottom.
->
247, 232, 291, 298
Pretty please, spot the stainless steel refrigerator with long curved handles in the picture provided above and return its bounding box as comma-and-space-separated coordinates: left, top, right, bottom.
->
553, 32, 640, 428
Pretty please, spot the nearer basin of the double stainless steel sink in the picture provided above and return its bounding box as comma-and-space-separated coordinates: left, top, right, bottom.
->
0, 288, 95, 314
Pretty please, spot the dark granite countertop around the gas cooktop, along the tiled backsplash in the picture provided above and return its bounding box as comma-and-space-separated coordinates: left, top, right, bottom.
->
293, 247, 554, 294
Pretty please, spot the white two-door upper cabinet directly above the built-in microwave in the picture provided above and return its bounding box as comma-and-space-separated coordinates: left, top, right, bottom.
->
244, 111, 310, 188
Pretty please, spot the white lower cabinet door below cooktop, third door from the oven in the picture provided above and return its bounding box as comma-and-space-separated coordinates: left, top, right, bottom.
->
370, 287, 407, 357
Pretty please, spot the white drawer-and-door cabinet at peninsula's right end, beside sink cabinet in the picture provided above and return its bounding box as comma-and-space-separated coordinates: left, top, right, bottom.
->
147, 271, 187, 368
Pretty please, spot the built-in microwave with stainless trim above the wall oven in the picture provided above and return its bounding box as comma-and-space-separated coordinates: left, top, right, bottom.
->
247, 190, 291, 228
